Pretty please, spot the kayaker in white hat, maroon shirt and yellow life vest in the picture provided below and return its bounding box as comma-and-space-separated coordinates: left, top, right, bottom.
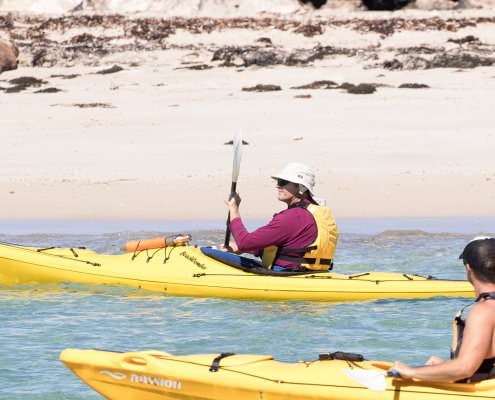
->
225, 162, 338, 271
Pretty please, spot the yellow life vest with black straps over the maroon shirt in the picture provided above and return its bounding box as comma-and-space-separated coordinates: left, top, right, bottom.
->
261, 203, 339, 271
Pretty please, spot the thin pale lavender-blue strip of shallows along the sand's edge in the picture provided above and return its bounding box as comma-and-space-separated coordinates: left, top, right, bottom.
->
0, 217, 495, 239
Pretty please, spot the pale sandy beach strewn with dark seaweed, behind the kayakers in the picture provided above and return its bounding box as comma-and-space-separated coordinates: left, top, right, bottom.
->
0, 1, 495, 220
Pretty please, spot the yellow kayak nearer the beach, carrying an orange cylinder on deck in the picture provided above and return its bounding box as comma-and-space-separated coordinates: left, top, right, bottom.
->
0, 245, 474, 301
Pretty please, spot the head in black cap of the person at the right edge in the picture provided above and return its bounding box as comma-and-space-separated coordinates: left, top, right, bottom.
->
459, 238, 495, 283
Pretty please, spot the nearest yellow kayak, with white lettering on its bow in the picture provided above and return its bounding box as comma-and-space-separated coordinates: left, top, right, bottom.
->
60, 349, 495, 400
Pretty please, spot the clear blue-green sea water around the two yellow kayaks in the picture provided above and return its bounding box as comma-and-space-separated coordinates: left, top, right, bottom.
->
0, 219, 495, 400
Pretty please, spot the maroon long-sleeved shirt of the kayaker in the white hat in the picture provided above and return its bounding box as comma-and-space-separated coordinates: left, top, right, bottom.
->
230, 203, 318, 268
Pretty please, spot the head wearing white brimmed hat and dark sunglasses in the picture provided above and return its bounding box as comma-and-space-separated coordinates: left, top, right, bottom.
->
272, 162, 315, 204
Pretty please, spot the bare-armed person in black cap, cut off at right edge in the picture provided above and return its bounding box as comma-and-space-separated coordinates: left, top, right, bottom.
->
392, 237, 495, 382
